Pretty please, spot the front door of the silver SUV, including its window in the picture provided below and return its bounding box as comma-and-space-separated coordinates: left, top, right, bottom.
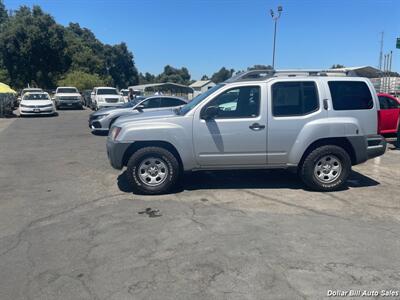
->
193, 84, 267, 168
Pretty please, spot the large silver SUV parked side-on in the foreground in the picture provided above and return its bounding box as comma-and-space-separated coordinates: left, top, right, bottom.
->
107, 70, 386, 194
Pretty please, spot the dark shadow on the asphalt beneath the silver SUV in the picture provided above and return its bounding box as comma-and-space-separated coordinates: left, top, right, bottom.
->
118, 170, 380, 193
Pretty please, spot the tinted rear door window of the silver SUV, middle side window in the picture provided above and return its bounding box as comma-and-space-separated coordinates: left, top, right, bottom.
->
272, 81, 319, 117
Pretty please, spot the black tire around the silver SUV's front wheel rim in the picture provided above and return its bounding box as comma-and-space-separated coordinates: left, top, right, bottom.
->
126, 147, 180, 195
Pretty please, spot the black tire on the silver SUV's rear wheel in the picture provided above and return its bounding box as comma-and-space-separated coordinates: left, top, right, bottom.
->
299, 145, 351, 192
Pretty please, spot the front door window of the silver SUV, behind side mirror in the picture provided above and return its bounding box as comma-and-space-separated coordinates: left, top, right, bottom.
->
202, 86, 260, 119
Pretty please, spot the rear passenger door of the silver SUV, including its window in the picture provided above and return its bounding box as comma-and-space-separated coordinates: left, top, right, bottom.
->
268, 79, 327, 165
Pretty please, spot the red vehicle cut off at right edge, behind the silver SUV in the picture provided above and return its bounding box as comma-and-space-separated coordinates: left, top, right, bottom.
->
378, 93, 400, 136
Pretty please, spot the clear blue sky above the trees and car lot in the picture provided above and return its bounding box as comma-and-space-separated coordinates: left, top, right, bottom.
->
4, 0, 400, 79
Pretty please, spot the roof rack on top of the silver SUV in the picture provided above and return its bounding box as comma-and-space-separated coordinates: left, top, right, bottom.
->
225, 69, 357, 83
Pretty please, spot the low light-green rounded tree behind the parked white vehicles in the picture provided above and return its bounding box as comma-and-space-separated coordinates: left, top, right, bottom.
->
57, 71, 108, 91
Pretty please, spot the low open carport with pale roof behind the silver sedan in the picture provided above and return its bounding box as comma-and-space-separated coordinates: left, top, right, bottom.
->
129, 82, 194, 99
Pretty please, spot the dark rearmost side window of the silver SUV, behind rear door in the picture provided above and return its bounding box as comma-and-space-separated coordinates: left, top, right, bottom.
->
328, 81, 374, 110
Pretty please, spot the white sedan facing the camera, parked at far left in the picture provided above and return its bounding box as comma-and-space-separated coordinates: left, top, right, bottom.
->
19, 92, 56, 116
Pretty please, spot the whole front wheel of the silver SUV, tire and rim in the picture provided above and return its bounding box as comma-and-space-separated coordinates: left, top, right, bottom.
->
127, 147, 179, 195
